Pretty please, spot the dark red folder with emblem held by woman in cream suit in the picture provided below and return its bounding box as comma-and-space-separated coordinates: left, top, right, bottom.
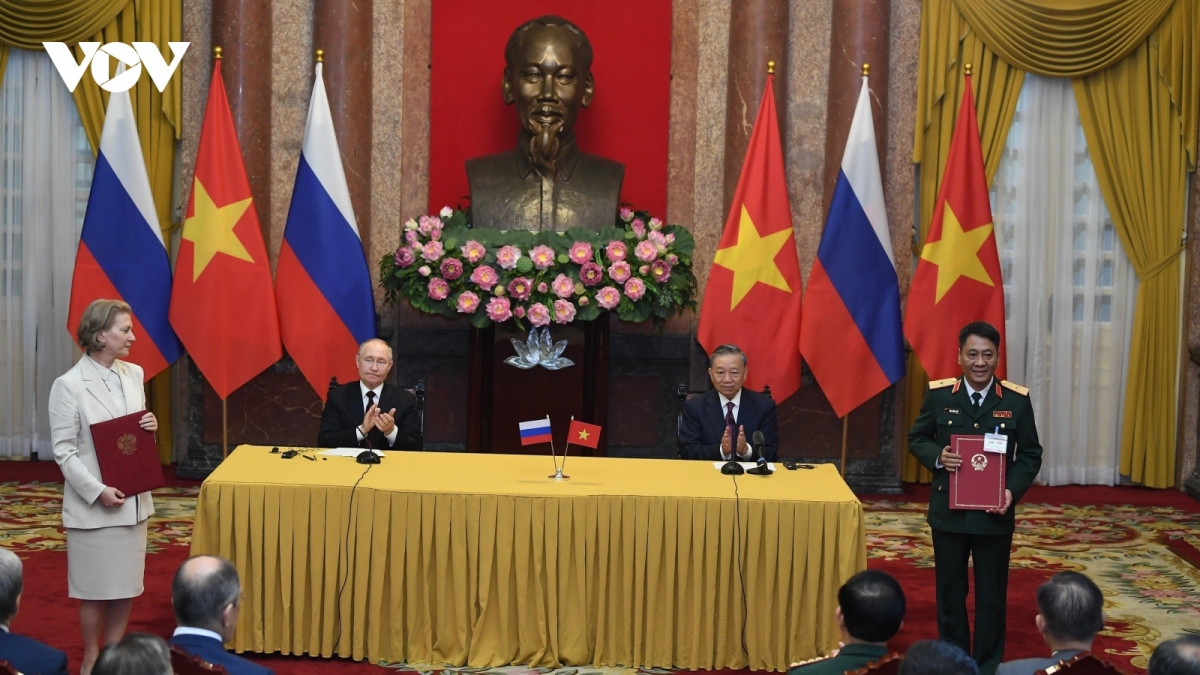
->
91, 411, 167, 497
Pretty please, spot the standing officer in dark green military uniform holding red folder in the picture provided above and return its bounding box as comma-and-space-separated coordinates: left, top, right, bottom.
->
908, 322, 1042, 675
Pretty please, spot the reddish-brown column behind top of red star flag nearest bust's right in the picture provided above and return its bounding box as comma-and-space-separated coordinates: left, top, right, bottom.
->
721, 0, 788, 214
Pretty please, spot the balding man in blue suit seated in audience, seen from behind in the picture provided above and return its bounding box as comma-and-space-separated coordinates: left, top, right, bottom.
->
170, 555, 272, 675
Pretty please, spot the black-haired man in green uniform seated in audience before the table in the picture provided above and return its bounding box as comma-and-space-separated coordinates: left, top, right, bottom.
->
787, 569, 905, 675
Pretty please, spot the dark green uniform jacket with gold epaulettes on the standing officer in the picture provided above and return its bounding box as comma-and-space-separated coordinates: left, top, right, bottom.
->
908, 377, 1042, 534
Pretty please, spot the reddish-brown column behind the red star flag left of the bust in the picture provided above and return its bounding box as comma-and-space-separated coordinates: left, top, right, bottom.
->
212, 0, 274, 241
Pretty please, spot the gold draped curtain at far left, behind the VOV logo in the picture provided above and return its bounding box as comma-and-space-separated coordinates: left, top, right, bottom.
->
0, 0, 184, 462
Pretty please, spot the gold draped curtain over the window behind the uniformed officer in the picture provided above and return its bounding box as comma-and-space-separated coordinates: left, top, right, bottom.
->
902, 0, 1200, 488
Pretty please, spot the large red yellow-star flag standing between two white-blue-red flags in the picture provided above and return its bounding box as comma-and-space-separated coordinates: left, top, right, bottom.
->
170, 60, 283, 399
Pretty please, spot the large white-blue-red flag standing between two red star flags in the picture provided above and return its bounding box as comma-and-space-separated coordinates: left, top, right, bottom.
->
800, 76, 904, 417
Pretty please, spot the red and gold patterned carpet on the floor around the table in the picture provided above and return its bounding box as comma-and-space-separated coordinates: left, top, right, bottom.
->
0, 470, 1200, 675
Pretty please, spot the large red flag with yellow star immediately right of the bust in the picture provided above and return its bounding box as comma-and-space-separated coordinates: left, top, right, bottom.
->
696, 74, 800, 401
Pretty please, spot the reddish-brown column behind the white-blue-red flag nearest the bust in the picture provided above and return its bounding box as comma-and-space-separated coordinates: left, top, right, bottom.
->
312, 0, 373, 251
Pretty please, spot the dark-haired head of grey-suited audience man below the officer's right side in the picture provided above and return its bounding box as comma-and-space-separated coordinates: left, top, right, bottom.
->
1036, 572, 1104, 651
